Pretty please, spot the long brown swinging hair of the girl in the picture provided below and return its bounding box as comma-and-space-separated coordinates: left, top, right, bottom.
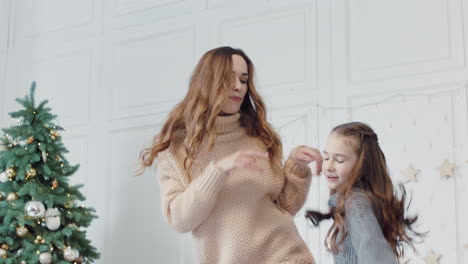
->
306, 122, 425, 257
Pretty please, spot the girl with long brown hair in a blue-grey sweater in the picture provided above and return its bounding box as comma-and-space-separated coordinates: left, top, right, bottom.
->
306, 122, 422, 264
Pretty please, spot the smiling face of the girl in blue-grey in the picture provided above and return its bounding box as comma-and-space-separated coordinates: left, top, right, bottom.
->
322, 133, 358, 190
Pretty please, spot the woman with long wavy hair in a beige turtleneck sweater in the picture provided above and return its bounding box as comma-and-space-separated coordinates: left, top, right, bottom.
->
142, 47, 322, 264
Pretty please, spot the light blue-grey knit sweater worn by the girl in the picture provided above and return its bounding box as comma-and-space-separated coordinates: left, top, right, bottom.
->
328, 192, 398, 264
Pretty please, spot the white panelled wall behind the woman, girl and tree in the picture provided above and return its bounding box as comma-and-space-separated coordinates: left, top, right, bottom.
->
0, 0, 468, 264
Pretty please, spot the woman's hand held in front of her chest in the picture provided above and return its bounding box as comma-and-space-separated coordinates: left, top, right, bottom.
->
215, 151, 268, 172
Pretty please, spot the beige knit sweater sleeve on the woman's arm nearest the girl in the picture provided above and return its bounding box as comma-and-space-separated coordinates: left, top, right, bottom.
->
279, 152, 312, 216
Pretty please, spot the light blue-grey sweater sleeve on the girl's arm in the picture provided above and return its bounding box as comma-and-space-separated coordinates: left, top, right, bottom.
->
346, 194, 398, 264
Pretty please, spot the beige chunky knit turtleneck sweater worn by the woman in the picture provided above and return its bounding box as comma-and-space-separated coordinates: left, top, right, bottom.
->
157, 113, 314, 264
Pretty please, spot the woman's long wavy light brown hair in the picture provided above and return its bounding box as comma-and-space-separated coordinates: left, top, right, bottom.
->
140, 47, 282, 178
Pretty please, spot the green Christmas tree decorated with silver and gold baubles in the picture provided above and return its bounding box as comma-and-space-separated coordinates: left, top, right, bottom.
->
0, 83, 99, 264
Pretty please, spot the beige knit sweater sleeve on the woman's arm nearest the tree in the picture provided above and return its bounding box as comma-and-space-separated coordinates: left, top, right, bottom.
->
157, 151, 226, 233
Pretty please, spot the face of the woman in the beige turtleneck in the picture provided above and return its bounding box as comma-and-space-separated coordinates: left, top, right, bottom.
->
221, 54, 249, 115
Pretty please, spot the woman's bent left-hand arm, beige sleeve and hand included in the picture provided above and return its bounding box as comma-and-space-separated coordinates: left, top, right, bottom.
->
158, 150, 268, 233
